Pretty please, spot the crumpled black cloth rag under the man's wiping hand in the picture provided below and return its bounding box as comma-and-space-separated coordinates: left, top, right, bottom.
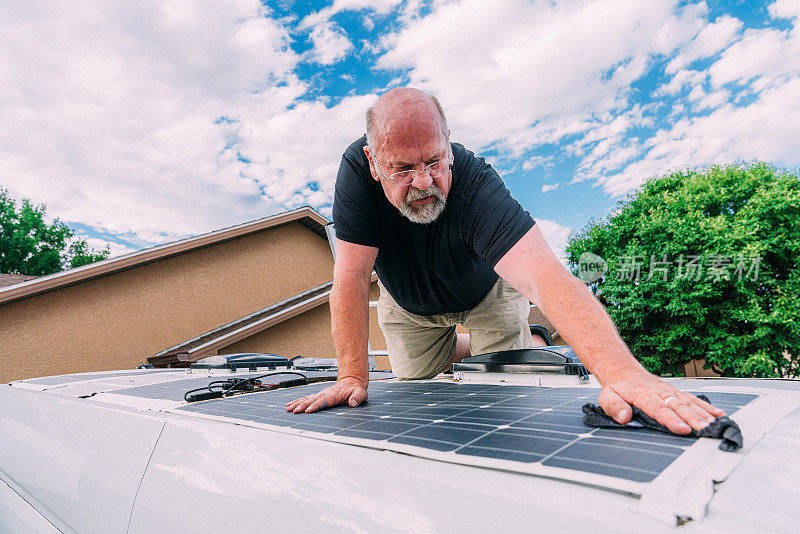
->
583, 395, 744, 452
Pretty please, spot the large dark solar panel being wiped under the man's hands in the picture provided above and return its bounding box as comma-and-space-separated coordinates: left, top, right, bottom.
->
176, 381, 757, 482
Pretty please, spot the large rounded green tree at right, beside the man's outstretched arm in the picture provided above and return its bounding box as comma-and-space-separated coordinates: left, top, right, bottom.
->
567, 163, 800, 377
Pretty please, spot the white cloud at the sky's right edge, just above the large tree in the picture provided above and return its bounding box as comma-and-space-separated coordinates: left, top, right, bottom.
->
599, 1, 800, 196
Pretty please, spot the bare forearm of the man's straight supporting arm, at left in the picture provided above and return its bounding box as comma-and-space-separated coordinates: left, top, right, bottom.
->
330, 275, 370, 383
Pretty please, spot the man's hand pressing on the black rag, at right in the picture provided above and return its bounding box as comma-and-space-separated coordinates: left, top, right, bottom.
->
599, 371, 725, 434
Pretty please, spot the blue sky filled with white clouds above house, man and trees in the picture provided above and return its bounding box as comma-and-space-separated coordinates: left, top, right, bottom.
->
0, 0, 800, 255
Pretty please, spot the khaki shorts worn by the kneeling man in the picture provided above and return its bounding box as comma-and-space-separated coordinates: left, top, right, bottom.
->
378, 278, 533, 379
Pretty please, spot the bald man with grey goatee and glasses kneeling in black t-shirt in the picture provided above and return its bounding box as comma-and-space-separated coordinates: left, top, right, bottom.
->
287, 88, 724, 434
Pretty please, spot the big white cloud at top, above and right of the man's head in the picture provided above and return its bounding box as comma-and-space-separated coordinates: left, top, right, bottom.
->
378, 0, 705, 154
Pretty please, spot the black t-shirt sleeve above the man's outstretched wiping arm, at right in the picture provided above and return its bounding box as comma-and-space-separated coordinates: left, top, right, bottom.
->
461, 158, 535, 267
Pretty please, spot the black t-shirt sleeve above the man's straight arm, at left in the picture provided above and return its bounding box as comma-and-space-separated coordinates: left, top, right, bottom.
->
333, 138, 380, 247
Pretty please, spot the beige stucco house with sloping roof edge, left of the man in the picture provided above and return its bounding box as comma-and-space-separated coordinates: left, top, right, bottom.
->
0, 208, 384, 382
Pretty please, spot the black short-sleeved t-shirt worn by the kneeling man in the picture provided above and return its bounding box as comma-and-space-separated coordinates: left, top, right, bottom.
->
333, 137, 534, 315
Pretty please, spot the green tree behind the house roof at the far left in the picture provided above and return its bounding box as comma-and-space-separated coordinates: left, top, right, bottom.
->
0, 188, 109, 276
